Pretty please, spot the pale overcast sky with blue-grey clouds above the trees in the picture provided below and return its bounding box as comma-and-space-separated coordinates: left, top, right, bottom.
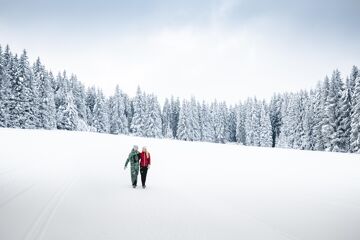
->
0, 0, 360, 103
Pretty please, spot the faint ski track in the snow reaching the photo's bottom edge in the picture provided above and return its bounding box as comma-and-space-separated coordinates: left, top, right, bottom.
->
24, 178, 75, 240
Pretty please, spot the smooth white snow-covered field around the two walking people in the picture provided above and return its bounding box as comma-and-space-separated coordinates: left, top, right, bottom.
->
0, 129, 360, 240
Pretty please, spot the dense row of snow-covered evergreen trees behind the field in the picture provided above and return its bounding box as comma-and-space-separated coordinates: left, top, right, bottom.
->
0, 45, 360, 153
